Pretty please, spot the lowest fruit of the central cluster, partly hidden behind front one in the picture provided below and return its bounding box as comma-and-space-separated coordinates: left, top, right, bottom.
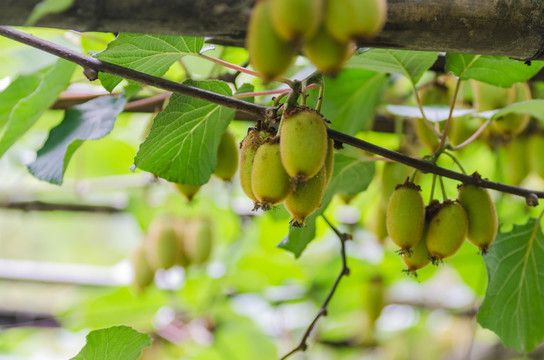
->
285, 167, 326, 227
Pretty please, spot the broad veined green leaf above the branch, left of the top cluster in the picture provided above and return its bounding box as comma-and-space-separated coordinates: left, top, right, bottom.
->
96, 33, 204, 91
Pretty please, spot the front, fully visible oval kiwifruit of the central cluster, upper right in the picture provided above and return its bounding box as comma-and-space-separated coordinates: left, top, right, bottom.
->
280, 106, 328, 183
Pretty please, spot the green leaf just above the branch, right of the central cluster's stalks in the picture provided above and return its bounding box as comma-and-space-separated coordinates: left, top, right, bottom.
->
321, 69, 387, 135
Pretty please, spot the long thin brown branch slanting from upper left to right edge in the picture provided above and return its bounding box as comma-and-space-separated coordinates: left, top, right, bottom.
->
0, 26, 544, 206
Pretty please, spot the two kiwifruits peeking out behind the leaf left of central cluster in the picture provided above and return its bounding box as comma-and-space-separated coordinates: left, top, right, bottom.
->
174, 130, 238, 201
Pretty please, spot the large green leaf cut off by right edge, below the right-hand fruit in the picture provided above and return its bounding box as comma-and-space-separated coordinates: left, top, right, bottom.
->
478, 219, 544, 353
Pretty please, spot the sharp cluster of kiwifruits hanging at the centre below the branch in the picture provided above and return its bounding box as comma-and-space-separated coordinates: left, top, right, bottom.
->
240, 106, 334, 227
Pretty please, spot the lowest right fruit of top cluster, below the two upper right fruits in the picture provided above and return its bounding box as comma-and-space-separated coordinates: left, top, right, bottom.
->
303, 26, 352, 75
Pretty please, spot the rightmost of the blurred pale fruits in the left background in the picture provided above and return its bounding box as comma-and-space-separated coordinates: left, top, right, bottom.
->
183, 218, 213, 265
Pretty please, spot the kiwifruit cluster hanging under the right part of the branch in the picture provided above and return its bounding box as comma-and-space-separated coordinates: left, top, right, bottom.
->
386, 179, 498, 274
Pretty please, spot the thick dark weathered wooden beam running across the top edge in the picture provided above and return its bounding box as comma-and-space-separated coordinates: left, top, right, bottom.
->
0, 0, 544, 60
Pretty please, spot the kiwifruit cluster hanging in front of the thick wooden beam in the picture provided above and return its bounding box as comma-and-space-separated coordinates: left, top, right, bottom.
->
247, 0, 387, 81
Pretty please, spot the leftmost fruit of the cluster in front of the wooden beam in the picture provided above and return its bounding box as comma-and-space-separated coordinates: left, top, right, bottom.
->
247, 0, 296, 82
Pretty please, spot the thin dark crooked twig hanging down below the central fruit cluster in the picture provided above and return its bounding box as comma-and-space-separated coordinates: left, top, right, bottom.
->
281, 214, 351, 360
